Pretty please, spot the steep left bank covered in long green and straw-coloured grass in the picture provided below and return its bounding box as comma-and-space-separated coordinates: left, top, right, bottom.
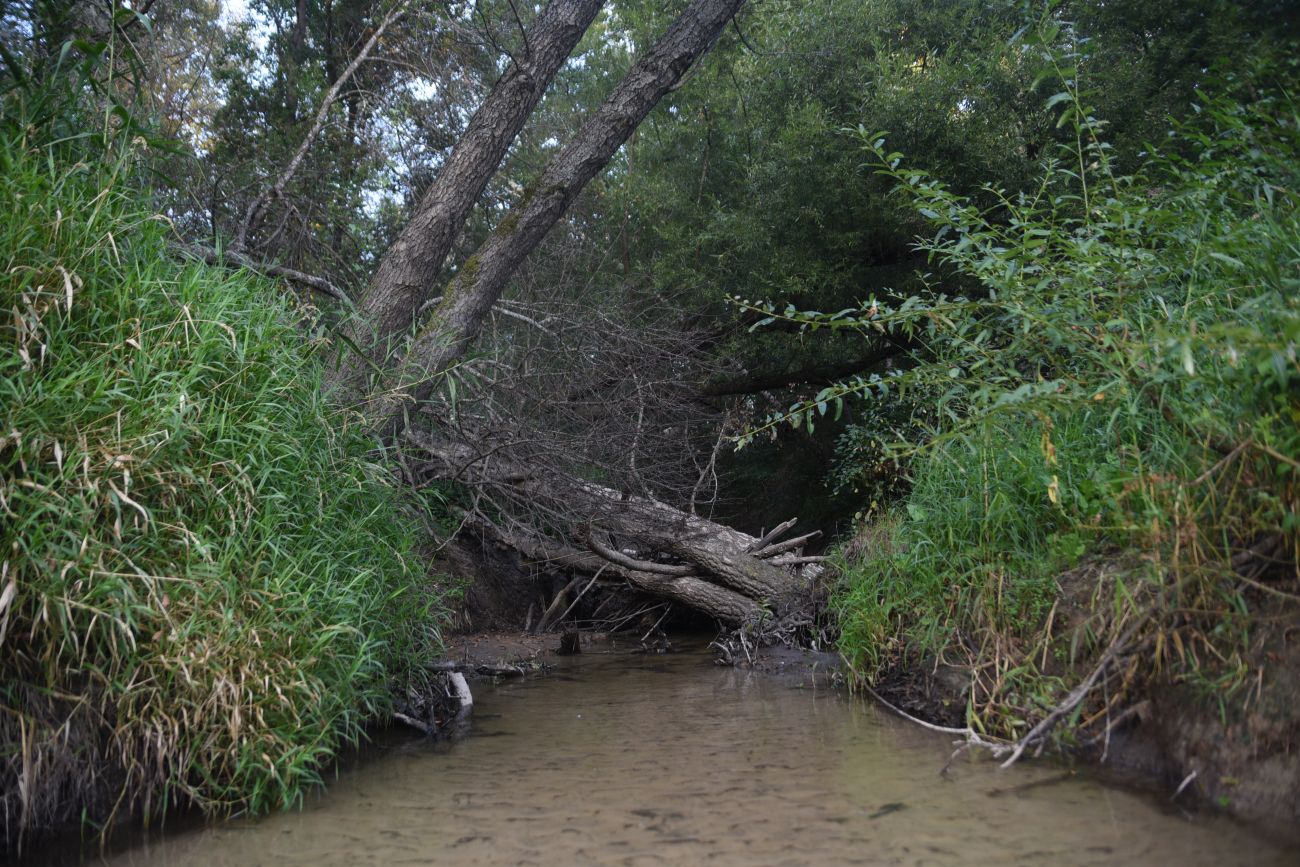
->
0, 90, 438, 846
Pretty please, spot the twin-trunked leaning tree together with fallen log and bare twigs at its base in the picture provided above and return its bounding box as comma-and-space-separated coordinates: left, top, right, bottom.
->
213, 0, 816, 625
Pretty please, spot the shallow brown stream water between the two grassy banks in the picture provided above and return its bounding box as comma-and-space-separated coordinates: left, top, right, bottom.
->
94, 642, 1296, 867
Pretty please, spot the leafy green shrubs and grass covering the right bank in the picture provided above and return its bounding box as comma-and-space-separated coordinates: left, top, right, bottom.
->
748, 35, 1300, 737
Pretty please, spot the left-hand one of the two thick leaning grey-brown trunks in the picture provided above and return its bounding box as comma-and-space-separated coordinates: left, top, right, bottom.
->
339, 0, 603, 385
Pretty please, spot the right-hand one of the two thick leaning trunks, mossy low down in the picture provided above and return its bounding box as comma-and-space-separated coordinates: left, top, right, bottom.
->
369, 0, 745, 434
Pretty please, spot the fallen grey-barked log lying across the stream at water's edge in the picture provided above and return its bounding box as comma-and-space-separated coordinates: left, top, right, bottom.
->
407, 430, 819, 625
